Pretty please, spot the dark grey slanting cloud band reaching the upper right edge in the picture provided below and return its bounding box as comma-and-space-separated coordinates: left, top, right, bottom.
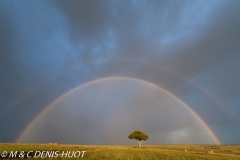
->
165, 1, 240, 77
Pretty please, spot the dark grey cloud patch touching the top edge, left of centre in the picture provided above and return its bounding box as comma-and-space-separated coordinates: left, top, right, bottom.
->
52, 0, 111, 42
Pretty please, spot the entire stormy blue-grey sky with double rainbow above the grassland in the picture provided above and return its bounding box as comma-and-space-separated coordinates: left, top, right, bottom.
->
0, 0, 240, 144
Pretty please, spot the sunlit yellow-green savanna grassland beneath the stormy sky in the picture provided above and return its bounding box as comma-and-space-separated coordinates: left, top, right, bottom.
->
0, 143, 240, 160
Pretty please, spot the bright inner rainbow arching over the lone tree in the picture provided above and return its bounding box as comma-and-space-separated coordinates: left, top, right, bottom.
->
16, 76, 221, 144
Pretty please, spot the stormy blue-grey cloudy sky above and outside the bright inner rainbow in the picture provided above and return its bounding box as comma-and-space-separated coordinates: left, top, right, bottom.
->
0, 0, 240, 143
